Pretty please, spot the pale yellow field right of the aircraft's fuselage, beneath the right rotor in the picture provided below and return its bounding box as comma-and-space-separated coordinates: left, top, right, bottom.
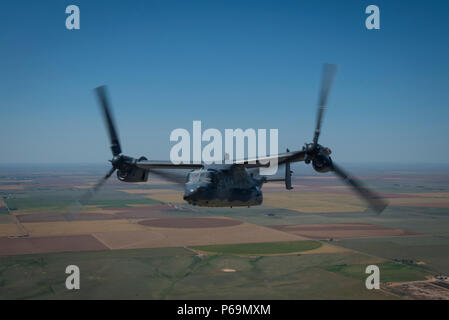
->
263, 191, 366, 213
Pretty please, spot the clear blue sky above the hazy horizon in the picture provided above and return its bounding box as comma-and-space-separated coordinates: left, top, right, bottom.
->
0, 0, 449, 164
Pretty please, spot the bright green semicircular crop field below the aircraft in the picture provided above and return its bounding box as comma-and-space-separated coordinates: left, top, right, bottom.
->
190, 240, 321, 255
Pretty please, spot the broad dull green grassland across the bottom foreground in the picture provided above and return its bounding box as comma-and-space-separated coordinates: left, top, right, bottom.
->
0, 248, 404, 299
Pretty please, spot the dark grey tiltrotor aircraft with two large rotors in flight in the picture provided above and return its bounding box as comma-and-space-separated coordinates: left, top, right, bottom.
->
84, 64, 387, 213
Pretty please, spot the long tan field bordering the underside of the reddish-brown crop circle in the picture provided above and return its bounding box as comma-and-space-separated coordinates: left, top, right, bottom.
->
17, 217, 305, 249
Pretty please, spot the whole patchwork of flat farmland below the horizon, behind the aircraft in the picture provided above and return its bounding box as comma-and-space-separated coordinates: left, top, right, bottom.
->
0, 167, 449, 299
